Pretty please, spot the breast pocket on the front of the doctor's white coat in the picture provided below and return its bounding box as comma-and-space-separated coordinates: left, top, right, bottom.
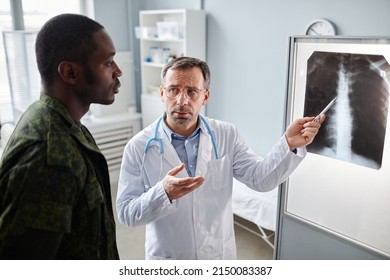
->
206, 155, 233, 190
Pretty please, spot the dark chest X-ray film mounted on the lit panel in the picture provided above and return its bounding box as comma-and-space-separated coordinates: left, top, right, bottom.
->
304, 52, 390, 169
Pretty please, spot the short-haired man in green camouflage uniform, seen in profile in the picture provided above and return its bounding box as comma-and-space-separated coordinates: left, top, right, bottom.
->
0, 14, 122, 259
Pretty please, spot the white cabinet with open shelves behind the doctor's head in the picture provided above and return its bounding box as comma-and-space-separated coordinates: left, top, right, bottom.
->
136, 9, 206, 127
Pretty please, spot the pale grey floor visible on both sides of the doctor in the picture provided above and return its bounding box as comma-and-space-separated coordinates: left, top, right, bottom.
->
112, 184, 273, 260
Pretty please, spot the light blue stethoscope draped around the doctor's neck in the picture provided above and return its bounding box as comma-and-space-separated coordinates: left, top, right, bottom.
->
141, 115, 219, 189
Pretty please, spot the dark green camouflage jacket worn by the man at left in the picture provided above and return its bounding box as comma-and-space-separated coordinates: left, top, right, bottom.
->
0, 94, 119, 259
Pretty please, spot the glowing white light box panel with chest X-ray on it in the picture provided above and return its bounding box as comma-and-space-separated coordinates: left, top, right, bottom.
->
283, 37, 390, 256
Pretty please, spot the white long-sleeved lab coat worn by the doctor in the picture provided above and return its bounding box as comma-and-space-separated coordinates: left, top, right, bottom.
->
117, 115, 306, 259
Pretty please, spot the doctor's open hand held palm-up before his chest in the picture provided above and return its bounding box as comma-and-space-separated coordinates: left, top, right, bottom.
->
163, 163, 204, 200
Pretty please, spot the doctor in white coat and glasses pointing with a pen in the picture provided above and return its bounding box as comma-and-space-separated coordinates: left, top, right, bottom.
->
117, 57, 325, 259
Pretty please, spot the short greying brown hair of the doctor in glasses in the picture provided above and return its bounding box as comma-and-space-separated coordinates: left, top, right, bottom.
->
161, 56, 210, 89
